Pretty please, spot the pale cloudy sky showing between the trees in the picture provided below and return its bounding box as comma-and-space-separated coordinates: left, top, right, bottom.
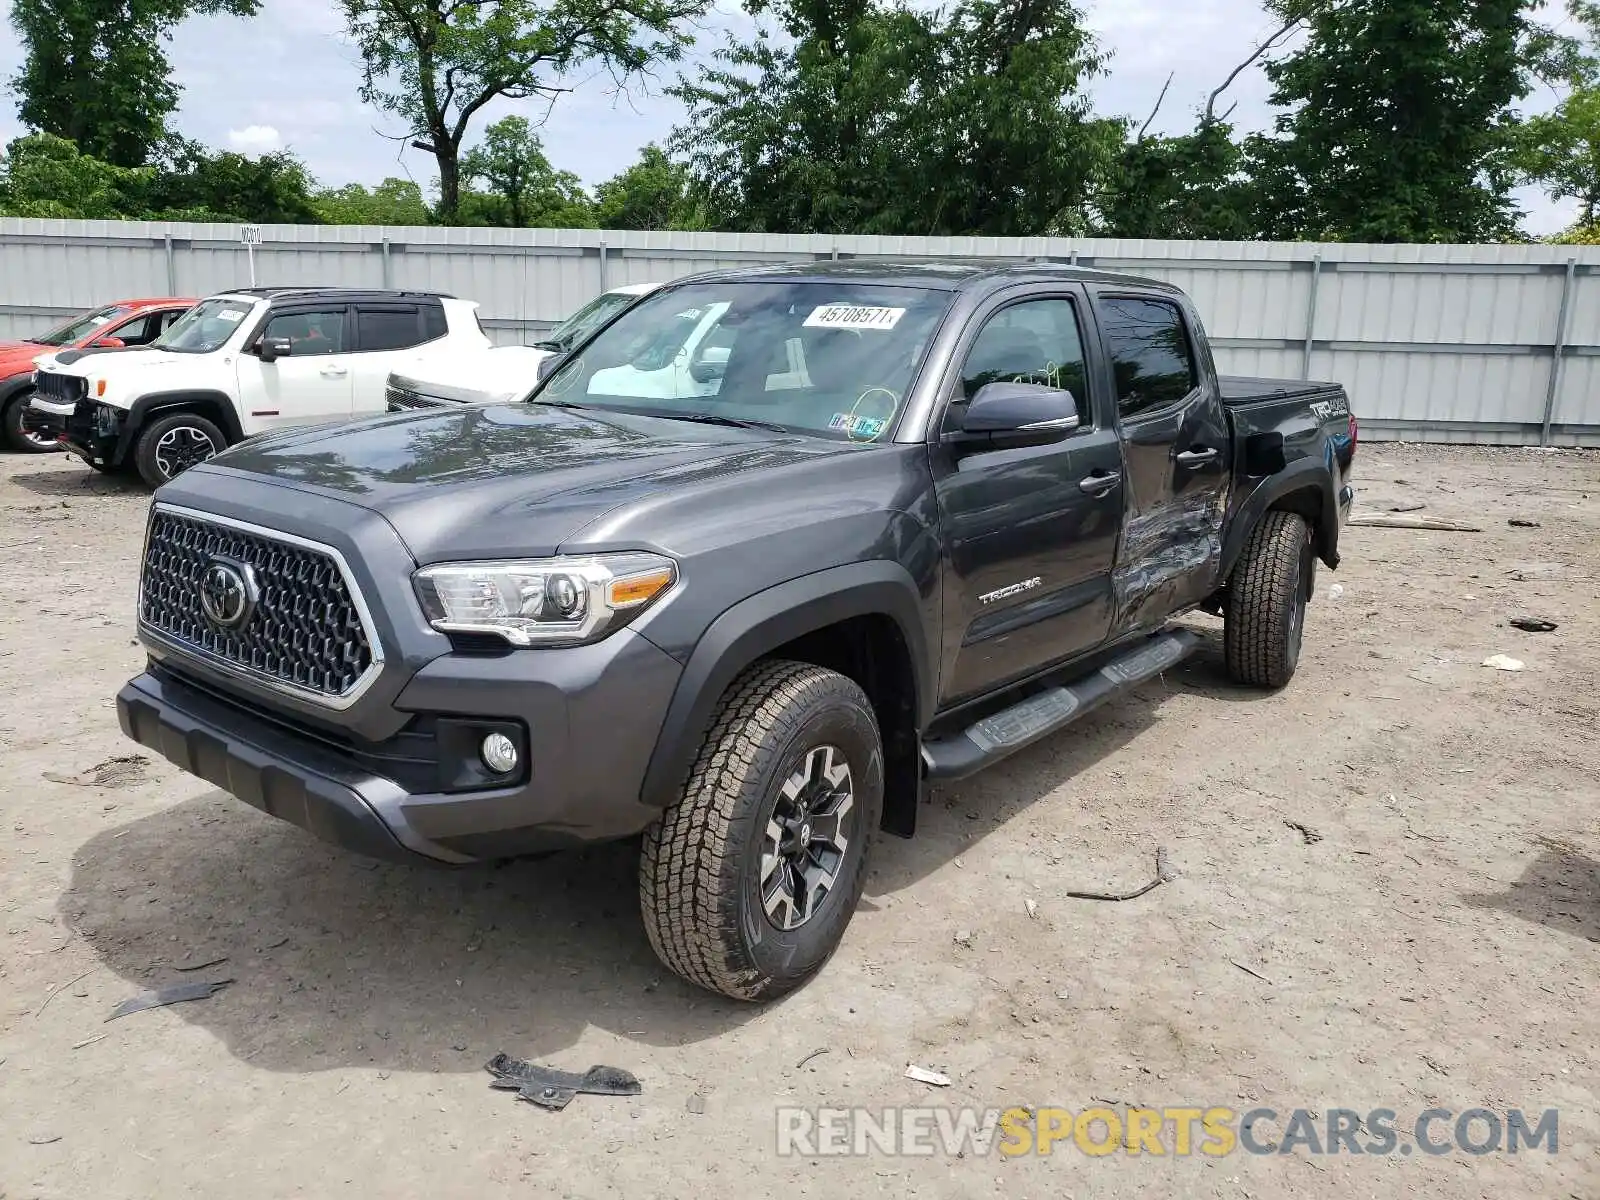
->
0, 0, 1571, 234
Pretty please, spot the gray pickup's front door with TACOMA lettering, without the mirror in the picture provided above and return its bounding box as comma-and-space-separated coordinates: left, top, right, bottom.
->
933, 294, 1123, 706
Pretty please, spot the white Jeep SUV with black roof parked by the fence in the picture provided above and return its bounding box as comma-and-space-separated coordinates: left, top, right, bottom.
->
32, 288, 490, 486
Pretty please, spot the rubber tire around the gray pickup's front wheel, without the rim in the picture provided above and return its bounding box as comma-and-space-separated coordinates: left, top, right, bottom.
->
638, 659, 883, 1000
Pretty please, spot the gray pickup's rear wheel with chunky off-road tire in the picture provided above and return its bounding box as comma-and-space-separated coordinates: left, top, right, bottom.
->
1222, 512, 1314, 688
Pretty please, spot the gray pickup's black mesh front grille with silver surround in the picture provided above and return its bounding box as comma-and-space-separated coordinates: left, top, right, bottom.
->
139, 506, 382, 707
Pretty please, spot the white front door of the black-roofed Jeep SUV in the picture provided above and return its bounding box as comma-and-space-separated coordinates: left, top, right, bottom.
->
238, 307, 352, 435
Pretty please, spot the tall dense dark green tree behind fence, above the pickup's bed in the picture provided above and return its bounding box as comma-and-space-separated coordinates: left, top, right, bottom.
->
1246, 0, 1539, 242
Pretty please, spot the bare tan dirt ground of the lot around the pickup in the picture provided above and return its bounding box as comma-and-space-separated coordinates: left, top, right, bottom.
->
0, 445, 1600, 1200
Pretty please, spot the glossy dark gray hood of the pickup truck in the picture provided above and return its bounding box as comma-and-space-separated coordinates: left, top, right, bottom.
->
192, 403, 850, 563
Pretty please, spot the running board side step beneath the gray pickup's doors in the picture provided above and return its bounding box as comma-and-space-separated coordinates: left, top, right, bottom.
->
922, 629, 1200, 790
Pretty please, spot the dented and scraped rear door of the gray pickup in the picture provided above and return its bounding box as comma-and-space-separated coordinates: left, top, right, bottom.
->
1094, 288, 1232, 634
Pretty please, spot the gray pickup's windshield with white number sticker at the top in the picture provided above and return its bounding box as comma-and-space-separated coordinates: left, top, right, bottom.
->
530, 280, 950, 442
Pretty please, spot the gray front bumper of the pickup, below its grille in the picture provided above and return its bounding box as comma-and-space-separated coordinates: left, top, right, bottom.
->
117, 629, 682, 864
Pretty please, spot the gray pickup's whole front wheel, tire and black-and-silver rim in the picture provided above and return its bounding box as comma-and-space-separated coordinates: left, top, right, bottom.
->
638, 661, 883, 1000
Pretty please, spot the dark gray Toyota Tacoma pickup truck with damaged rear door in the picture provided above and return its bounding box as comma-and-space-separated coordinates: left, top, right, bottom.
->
117, 259, 1357, 1000
